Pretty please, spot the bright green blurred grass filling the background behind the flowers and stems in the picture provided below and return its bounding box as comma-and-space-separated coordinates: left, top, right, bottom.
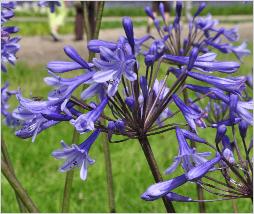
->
1, 1, 253, 213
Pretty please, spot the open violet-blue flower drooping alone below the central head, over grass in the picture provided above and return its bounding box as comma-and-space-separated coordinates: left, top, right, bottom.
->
52, 130, 100, 180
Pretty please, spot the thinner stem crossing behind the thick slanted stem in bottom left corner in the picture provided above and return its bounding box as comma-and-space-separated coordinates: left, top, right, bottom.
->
1, 137, 27, 213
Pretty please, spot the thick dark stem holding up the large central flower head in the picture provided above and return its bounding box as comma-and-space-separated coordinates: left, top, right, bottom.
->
139, 137, 175, 213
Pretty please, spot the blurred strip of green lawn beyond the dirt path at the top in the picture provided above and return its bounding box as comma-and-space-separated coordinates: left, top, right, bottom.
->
8, 1, 253, 36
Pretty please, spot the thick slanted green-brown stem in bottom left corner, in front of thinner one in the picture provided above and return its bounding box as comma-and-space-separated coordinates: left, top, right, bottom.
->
1, 160, 39, 213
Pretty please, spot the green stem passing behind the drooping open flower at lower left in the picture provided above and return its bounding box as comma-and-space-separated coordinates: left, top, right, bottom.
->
61, 129, 79, 213
